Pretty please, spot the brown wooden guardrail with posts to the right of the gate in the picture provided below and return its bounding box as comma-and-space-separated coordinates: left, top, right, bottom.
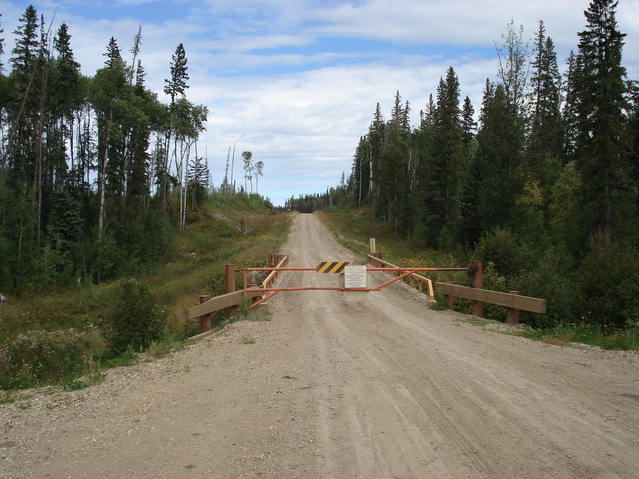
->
368, 253, 547, 324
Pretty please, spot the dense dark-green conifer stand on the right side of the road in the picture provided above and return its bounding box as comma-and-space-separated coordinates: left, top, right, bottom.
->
348, 0, 639, 329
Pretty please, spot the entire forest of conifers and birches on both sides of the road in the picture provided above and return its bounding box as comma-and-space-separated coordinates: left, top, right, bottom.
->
0, 0, 639, 340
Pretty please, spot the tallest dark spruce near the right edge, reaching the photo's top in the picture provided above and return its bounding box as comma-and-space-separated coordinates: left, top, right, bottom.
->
576, 0, 635, 239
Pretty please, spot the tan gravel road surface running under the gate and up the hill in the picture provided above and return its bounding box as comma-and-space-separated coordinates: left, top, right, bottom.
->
0, 215, 639, 479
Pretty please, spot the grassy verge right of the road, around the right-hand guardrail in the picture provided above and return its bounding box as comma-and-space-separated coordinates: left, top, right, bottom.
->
318, 209, 639, 351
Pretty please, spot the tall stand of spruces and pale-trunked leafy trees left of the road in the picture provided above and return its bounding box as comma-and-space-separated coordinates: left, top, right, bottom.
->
0, 6, 209, 293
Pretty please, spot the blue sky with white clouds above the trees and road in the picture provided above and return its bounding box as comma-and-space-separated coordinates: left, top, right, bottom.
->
0, 0, 639, 205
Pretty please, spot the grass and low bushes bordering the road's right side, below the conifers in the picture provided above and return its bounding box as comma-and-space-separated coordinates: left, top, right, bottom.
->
317, 205, 639, 351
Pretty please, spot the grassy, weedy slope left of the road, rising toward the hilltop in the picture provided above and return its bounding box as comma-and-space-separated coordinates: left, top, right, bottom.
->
0, 195, 289, 389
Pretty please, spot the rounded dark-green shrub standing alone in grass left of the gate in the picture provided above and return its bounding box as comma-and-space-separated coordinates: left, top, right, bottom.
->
103, 280, 168, 352
